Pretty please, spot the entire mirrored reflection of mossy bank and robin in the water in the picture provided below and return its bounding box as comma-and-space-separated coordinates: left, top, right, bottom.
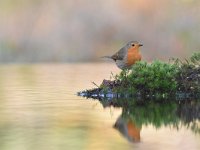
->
100, 99, 200, 142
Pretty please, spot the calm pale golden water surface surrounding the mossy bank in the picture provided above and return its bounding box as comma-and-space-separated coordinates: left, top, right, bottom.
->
0, 64, 200, 150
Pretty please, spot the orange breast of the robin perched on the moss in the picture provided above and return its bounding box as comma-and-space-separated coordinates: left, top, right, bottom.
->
127, 47, 142, 66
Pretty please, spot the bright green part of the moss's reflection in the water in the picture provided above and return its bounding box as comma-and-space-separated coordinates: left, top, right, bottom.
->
122, 102, 178, 128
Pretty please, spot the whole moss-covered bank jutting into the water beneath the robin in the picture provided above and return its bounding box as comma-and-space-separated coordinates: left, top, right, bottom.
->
78, 53, 200, 99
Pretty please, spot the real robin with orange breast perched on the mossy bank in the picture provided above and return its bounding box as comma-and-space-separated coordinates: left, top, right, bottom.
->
103, 41, 142, 69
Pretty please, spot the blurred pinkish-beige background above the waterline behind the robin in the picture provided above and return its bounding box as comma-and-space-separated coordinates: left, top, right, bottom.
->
0, 0, 200, 63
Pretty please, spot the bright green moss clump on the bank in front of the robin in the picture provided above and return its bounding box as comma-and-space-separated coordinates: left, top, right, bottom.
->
114, 60, 179, 96
